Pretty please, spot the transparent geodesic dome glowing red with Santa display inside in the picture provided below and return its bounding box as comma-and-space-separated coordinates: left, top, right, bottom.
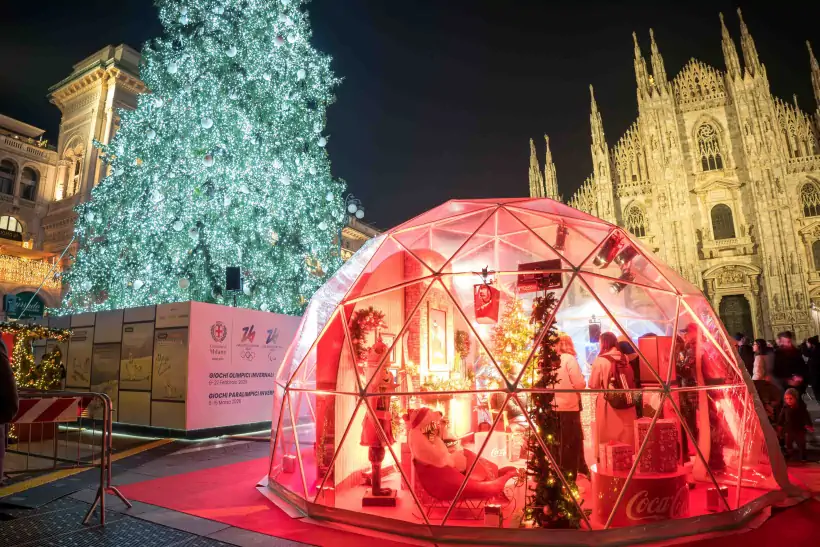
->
268, 199, 793, 545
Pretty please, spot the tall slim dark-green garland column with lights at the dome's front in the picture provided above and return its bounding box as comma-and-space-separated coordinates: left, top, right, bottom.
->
525, 293, 583, 528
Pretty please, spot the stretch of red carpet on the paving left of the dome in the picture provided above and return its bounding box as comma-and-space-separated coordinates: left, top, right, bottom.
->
121, 458, 416, 547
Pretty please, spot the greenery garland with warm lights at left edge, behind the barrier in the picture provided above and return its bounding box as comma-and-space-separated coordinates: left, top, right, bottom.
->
0, 323, 71, 390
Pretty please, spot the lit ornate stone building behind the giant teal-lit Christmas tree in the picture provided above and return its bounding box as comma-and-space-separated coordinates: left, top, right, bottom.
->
0, 45, 378, 317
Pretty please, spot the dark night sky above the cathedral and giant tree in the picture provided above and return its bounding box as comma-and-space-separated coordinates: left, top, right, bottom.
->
0, 0, 820, 228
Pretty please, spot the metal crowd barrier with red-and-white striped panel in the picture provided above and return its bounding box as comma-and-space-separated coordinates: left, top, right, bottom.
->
6, 390, 132, 525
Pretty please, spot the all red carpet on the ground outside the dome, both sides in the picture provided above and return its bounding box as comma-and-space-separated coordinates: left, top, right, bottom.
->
120, 458, 820, 547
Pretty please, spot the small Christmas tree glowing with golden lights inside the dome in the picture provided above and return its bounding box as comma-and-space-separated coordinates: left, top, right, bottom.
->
491, 298, 533, 385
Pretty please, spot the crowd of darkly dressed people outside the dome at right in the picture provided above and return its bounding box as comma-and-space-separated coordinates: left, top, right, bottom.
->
735, 331, 820, 461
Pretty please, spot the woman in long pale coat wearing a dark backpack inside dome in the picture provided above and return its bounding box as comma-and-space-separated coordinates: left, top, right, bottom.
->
589, 332, 637, 462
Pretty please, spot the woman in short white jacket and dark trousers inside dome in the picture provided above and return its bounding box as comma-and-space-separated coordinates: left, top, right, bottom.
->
555, 332, 589, 478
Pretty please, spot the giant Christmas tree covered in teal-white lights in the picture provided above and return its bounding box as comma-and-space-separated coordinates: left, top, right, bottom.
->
61, 0, 345, 313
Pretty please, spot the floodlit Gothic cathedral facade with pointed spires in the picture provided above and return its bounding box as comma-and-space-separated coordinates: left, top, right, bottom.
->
530, 10, 820, 338
